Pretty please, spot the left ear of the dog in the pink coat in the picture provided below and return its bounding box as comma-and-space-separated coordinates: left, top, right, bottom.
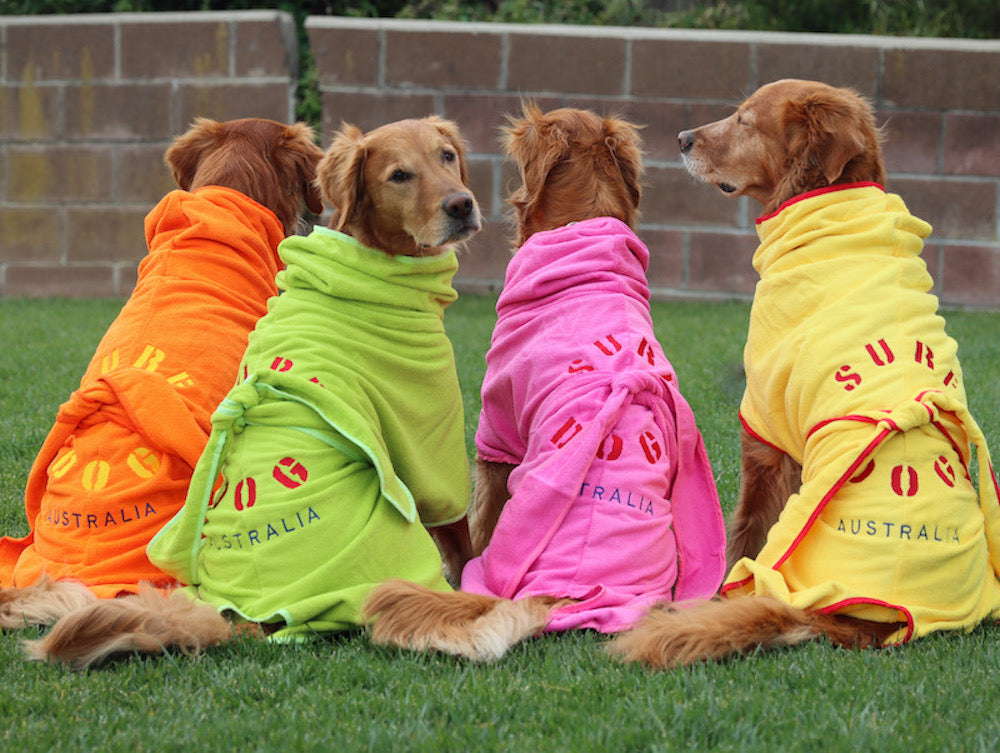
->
502, 102, 569, 219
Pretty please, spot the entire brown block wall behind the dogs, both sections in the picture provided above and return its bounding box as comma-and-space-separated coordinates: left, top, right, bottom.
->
0, 13, 1000, 308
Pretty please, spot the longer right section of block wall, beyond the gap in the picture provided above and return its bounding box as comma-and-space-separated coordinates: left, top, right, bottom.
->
306, 18, 1000, 307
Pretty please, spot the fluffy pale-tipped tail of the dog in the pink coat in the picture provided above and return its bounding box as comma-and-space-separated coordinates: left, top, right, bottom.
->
362, 580, 562, 662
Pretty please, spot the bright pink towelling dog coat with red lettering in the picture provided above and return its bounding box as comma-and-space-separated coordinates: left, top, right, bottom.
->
462, 217, 725, 632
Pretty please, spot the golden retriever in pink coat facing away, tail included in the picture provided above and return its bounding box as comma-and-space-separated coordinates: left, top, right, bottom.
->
365, 104, 725, 661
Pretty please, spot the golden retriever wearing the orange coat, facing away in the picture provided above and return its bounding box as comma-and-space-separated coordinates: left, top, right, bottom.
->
0, 118, 323, 629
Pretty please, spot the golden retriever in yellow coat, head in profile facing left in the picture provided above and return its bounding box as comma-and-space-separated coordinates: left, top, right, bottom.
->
612, 80, 1000, 667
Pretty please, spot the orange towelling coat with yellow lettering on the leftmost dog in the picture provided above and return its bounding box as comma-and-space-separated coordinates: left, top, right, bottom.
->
0, 187, 284, 597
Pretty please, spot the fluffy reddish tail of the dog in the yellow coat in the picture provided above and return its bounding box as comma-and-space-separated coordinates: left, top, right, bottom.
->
608, 596, 900, 669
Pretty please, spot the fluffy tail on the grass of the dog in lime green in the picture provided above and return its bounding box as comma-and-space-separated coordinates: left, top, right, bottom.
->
24, 588, 234, 669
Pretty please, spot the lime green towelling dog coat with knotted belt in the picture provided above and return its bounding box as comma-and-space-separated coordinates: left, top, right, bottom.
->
149, 228, 469, 640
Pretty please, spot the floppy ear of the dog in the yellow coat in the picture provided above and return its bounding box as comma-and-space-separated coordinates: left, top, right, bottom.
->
783, 89, 884, 195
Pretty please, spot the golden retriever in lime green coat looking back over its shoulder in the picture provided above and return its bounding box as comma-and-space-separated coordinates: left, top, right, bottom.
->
29, 117, 481, 667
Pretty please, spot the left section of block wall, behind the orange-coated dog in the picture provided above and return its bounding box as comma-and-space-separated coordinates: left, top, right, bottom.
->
0, 11, 298, 297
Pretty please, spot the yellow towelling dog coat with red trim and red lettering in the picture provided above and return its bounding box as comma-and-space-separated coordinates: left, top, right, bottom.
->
723, 184, 1000, 642
